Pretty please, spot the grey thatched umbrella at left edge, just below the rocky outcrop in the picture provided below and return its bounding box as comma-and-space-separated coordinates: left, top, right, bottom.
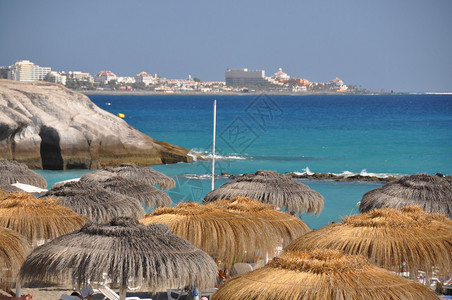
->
0, 159, 47, 189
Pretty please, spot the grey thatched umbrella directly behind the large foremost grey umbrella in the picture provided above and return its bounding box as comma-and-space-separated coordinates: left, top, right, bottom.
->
45, 182, 144, 223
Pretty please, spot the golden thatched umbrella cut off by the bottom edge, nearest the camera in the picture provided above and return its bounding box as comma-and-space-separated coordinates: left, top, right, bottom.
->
211, 250, 438, 300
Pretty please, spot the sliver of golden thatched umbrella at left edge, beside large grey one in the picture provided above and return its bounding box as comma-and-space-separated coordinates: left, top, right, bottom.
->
0, 226, 31, 285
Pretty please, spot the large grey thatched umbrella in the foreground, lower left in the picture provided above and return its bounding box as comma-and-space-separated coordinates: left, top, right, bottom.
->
20, 218, 217, 299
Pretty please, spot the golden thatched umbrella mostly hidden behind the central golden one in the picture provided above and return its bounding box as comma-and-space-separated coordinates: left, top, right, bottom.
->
208, 196, 311, 247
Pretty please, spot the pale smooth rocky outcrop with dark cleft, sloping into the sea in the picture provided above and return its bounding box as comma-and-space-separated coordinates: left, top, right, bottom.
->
0, 80, 192, 170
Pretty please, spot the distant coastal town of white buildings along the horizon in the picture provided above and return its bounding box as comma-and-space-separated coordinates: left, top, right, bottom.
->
0, 60, 371, 94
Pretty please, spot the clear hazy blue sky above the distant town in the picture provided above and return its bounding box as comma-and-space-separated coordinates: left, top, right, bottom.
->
0, 0, 452, 92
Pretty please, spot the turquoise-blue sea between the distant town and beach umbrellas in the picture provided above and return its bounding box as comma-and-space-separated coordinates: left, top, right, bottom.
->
38, 94, 452, 228
